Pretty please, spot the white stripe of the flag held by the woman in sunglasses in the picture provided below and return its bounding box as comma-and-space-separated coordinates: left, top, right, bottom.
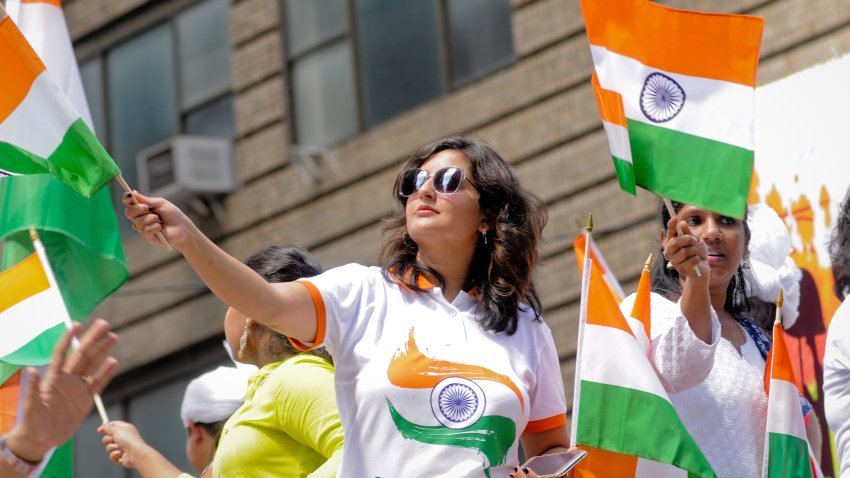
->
0, 71, 79, 158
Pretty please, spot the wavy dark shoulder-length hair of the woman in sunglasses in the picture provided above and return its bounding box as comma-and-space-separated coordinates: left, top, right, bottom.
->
380, 137, 547, 335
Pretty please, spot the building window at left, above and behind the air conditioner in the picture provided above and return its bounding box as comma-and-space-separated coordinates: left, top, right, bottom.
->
80, 0, 234, 223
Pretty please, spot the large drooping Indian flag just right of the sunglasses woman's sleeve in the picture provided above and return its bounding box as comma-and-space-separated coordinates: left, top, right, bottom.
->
571, 233, 717, 478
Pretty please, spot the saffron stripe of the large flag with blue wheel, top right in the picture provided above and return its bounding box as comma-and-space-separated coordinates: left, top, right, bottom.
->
581, 0, 764, 87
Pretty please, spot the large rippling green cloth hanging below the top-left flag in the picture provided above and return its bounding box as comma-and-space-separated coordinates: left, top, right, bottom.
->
0, 174, 128, 364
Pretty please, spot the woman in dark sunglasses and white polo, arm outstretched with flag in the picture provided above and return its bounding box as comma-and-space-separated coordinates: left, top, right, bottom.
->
125, 138, 568, 477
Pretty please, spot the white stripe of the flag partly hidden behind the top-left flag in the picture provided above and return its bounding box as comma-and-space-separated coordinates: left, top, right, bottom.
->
6, 0, 94, 131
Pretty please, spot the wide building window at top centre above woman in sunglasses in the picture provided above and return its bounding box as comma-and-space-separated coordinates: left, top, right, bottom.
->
283, 0, 515, 146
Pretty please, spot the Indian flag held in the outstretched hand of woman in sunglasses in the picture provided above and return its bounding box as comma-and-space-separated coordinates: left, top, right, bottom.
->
0, 1, 120, 197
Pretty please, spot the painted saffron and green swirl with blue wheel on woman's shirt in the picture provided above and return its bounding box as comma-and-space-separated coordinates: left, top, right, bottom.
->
387, 329, 525, 477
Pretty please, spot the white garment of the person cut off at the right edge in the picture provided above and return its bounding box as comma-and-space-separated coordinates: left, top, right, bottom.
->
823, 298, 850, 478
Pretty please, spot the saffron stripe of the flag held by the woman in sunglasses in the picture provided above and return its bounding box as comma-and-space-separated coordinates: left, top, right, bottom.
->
0, 16, 45, 122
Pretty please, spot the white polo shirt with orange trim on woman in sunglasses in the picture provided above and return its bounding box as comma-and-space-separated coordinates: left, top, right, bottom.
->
296, 264, 566, 478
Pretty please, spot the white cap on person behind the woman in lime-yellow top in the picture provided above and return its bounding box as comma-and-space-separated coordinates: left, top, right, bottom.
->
180, 367, 256, 428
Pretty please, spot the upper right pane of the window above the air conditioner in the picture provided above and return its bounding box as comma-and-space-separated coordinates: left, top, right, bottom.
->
177, 0, 232, 110
